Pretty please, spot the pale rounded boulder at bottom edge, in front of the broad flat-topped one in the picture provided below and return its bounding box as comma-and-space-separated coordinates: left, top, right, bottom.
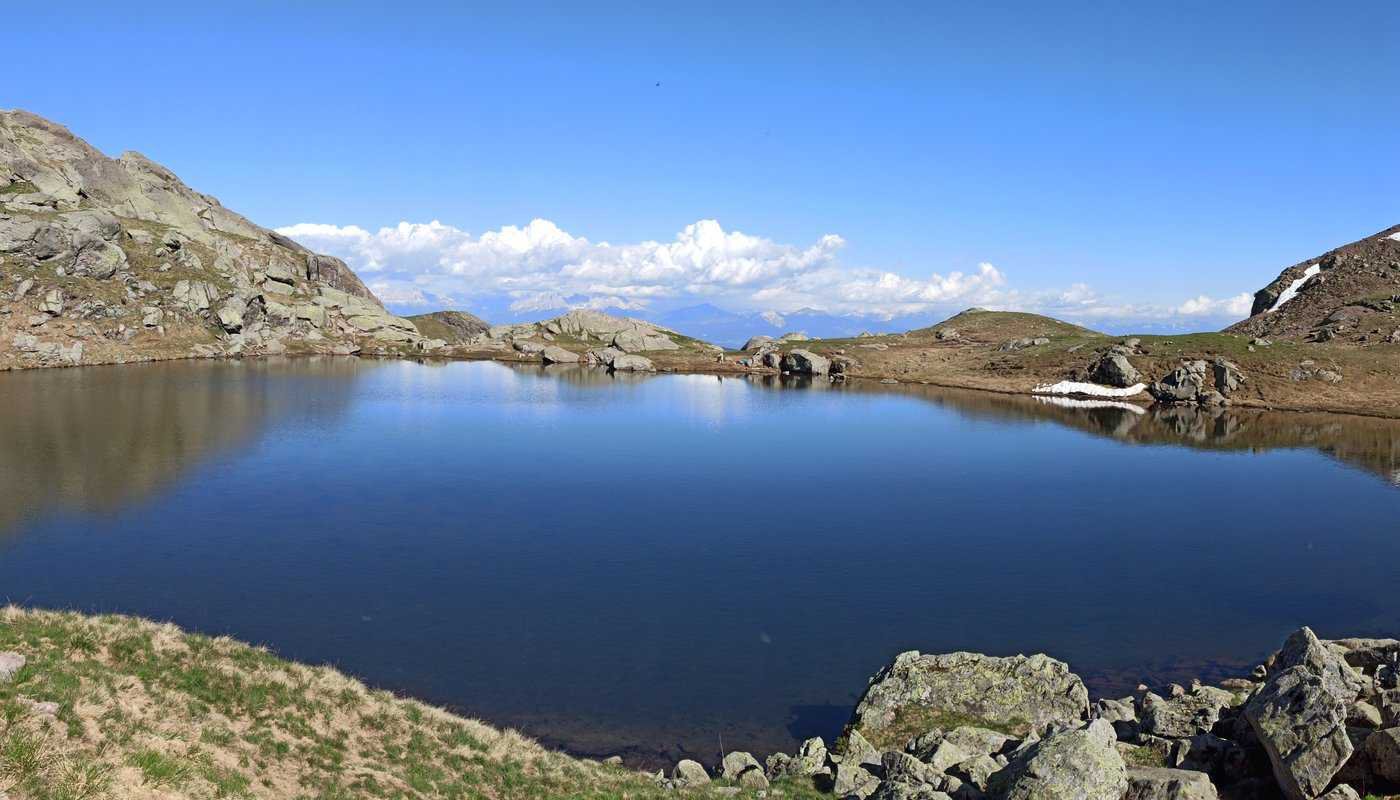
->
988, 720, 1128, 800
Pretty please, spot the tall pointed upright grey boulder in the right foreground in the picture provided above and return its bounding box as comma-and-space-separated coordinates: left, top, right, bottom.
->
1245, 628, 1364, 800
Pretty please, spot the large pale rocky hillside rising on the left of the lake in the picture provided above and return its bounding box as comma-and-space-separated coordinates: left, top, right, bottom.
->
0, 111, 435, 368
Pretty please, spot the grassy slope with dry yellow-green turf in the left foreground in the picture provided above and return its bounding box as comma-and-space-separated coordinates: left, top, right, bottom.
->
0, 607, 816, 800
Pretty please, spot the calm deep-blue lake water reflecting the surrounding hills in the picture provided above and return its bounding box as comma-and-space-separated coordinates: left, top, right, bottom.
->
0, 359, 1400, 764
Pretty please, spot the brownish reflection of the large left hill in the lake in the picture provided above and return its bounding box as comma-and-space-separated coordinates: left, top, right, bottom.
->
0, 357, 374, 534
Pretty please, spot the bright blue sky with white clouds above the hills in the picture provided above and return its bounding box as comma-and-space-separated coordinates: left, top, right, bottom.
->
0, 1, 1400, 328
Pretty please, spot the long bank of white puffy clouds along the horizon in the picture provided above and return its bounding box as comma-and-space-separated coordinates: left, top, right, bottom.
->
277, 219, 1253, 324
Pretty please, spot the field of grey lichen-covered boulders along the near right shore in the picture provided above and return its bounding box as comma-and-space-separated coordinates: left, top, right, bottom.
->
654, 628, 1400, 800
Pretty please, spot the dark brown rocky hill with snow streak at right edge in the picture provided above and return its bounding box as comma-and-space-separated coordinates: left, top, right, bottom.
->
1228, 226, 1400, 343
